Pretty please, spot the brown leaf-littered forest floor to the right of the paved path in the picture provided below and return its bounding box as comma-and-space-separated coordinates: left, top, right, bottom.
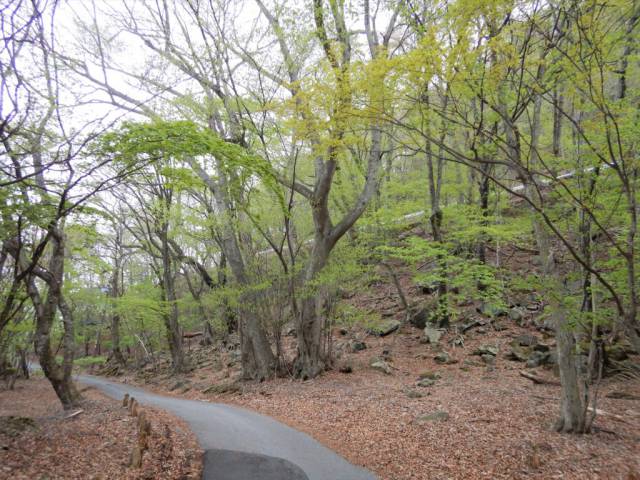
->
115, 325, 640, 480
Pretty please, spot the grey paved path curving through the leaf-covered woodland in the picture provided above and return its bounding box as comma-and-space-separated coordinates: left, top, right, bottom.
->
77, 375, 376, 480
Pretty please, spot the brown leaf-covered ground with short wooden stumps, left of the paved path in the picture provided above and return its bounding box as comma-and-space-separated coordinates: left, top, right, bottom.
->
0, 378, 202, 480
